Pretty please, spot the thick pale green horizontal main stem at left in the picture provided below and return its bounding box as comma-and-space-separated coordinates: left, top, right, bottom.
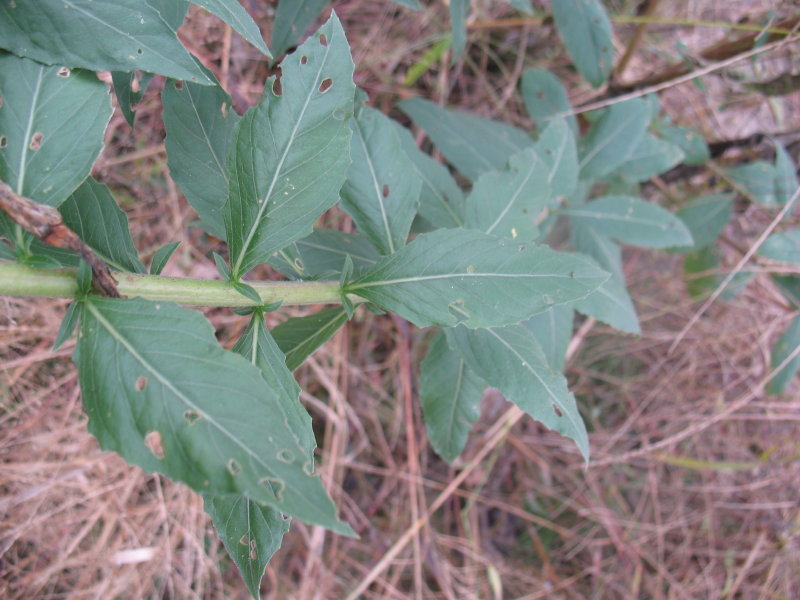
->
0, 261, 350, 307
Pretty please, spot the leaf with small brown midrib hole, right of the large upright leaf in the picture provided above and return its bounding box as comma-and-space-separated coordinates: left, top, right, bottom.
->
340, 106, 422, 254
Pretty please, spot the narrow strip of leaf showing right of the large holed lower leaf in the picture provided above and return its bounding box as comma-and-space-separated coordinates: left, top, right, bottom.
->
233, 311, 317, 458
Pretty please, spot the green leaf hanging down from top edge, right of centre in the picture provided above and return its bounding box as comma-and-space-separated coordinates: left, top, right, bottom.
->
552, 0, 614, 87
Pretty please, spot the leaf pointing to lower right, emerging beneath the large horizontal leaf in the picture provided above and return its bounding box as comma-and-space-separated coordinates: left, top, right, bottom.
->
447, 325, 589, 461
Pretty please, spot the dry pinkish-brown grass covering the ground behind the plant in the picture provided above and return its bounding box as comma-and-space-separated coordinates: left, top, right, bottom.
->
0, 0, 800, 600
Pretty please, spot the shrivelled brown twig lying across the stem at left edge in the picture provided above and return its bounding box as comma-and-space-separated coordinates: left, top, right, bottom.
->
0, 181, 120, 298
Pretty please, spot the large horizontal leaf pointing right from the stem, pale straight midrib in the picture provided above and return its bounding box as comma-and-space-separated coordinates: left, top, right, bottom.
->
345, 229, 608, 327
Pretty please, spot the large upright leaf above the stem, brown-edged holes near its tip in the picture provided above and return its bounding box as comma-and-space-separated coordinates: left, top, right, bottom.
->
224, 14, 355, 278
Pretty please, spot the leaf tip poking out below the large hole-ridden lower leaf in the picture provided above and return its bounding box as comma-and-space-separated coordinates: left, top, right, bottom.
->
203, 494, 290, 599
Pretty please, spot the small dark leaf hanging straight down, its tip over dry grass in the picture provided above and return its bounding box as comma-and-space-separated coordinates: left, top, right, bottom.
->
419, 332, 487, 464
